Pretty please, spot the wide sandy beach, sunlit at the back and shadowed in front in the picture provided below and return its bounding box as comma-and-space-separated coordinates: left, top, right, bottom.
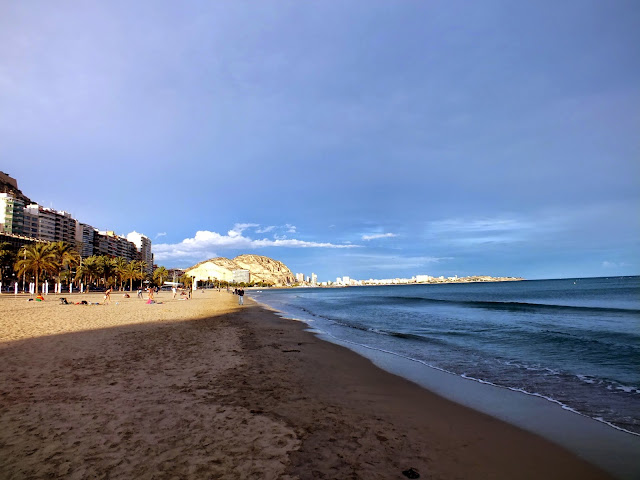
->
0, 291, 609, 479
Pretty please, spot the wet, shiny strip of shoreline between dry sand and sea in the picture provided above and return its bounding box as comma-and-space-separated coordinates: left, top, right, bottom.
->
252, 292, 640, 479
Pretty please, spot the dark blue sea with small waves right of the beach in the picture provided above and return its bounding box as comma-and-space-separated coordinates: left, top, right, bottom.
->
249, 276, 640, 435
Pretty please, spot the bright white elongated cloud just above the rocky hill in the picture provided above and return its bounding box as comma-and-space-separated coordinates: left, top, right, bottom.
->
153, 223, 358, 261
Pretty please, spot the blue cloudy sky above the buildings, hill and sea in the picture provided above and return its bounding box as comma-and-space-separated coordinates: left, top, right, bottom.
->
0, 0, 640, 281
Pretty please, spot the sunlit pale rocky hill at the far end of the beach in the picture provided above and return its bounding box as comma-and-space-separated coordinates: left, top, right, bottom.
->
185, 255, 295, 285
